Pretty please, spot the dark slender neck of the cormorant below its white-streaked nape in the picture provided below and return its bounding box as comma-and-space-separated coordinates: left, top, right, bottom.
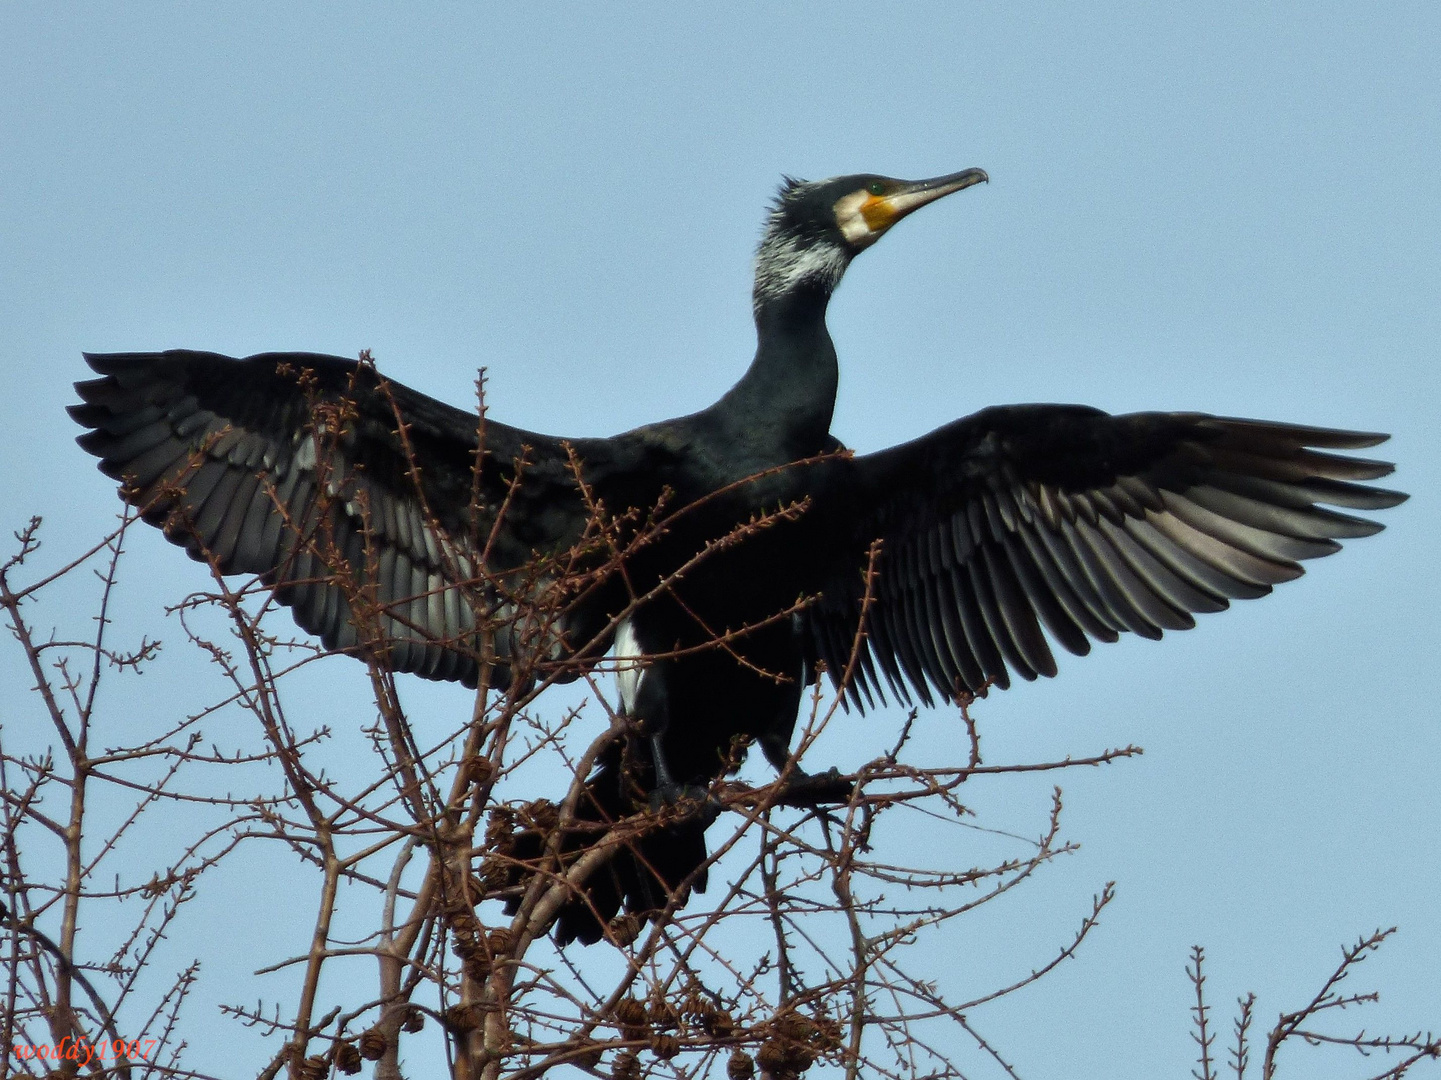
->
719, 284, 839, 463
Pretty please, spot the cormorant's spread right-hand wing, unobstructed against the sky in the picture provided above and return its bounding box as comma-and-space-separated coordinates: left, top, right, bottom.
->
807, 405, 1406, 705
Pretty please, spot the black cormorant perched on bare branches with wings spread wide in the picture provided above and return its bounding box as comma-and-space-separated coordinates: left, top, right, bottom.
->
71, 169, 1405, 940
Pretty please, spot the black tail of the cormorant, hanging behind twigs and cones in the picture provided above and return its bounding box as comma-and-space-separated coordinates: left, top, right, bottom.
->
504, 747, 713, 944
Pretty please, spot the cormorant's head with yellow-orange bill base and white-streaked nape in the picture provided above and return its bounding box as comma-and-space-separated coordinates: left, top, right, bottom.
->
755, 169, 989, 311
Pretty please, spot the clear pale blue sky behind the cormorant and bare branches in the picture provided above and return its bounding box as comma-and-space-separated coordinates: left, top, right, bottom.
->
0, 3, 1441, 1080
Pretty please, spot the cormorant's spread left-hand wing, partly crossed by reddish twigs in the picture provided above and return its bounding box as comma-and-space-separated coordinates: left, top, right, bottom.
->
71, 350, 599, 685
